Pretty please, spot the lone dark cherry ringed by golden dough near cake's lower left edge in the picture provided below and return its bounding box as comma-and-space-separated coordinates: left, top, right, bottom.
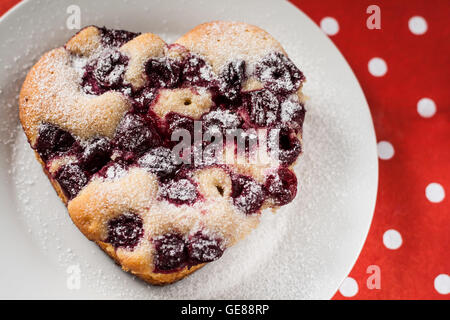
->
105, 212, 144, 249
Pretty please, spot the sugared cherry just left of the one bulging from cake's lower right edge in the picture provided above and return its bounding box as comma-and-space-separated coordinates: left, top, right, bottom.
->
231, 175, 266, 214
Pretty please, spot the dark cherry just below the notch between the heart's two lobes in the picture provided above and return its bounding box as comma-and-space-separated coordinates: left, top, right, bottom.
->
145, 59, 181, 88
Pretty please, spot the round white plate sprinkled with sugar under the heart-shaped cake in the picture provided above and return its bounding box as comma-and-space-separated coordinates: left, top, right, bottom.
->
0, 0, 378, 299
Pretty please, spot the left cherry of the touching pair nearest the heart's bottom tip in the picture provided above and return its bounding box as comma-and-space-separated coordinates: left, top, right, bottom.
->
153, 233, 188, 271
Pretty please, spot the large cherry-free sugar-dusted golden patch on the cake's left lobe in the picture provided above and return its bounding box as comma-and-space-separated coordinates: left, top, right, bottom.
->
23, 48, 128, 137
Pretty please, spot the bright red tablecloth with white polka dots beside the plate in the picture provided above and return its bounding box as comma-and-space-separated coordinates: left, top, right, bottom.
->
0, 0, 450, 299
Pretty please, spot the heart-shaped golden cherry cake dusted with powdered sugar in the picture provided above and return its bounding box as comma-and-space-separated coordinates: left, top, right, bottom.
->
20, 21, 305, 284
